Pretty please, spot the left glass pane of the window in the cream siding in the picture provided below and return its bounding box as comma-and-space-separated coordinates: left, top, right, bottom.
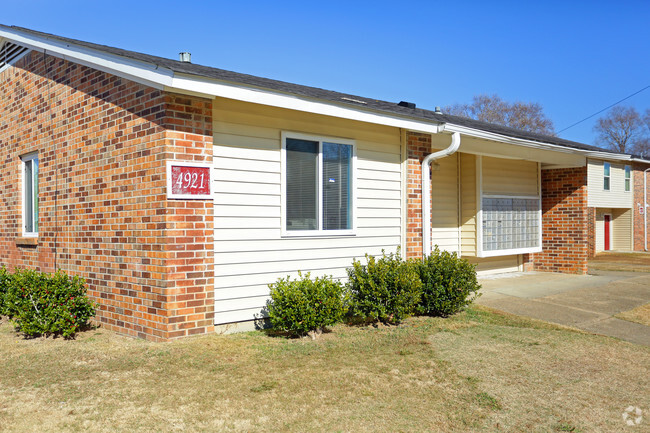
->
286, 138, 318, 230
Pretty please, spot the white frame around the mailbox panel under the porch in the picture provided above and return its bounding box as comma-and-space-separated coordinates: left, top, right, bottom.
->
476, 155, 543, 257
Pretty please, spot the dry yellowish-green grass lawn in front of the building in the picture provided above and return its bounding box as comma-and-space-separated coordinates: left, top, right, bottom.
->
0, 306, 650, 432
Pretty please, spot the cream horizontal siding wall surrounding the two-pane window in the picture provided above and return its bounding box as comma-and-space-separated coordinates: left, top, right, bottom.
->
213, 99, 402, 324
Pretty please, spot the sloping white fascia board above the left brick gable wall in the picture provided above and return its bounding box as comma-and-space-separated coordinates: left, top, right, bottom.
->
0, 27, 174, 89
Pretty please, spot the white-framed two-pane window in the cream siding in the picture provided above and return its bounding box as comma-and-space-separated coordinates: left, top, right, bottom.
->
282, 134, 355, 235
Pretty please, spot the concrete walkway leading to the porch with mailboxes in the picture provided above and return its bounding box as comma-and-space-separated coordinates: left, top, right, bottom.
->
476, 270, 650, 346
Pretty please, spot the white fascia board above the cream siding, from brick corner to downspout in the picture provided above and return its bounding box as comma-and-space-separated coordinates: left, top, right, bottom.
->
167, 74, 442, 134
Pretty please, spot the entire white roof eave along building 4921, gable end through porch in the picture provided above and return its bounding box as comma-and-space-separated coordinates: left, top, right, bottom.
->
0, 25, 632, 160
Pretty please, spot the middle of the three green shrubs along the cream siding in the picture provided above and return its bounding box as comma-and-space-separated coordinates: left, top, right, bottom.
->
348, 249, 422, 323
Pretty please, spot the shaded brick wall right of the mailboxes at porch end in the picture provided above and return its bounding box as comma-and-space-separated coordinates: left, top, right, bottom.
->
530, 167, 589, 274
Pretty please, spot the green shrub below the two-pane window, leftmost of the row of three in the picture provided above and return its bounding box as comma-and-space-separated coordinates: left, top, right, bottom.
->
267, 273, 345, 336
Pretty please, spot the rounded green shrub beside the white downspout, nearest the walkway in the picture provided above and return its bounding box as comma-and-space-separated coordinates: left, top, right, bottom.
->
418, 247, 481, 316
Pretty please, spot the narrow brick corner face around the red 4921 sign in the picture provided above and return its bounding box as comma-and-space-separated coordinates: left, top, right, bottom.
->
163, 93, 214, 339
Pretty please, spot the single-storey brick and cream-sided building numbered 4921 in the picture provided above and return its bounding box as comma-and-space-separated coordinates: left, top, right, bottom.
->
0, 26, 643, 340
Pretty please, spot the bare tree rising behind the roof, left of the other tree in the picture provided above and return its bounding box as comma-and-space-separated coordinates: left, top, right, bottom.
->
444, 95, 555, 135
